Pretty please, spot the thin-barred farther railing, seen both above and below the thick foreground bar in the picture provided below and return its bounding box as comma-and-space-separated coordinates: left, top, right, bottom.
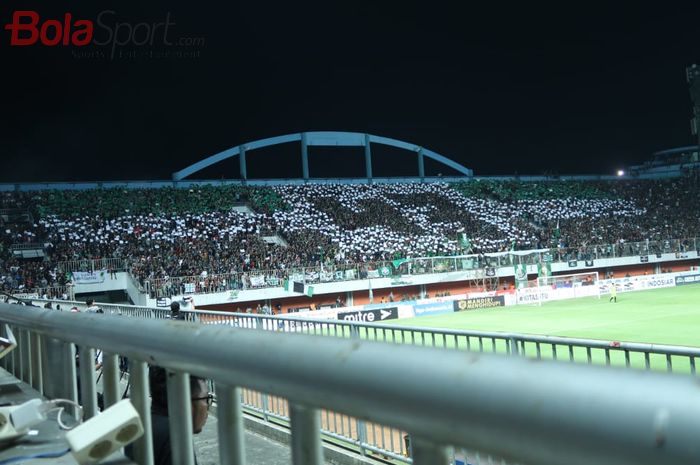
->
27, 302, 700, 464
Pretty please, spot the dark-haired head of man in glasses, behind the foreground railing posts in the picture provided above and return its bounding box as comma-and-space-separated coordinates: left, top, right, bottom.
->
148, 366, 209, 434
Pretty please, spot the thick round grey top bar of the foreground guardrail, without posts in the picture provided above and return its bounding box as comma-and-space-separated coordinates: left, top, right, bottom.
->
5, 304, 700, 465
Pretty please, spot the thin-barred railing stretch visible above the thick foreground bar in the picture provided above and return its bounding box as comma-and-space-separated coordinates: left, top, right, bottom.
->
34, 299, 700, 375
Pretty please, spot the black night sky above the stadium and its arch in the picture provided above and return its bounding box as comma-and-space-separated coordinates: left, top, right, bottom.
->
0, 1, 700, 182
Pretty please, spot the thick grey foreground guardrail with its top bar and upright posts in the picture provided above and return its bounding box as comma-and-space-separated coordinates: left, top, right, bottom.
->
0, 304, 700, 465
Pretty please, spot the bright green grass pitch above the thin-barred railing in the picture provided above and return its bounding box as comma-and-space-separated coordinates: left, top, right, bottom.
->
392, 285, 700, 347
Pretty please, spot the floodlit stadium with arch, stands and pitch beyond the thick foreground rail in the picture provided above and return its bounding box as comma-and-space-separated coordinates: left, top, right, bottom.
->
0, 120, 700, 463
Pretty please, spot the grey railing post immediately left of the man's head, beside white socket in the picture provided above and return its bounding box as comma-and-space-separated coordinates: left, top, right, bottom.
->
129, 360, 153, 465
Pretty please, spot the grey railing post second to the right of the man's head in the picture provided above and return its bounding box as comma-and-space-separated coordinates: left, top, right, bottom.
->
289, 402, 323, 465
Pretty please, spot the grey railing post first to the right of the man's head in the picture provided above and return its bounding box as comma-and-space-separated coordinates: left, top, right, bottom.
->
216, 384, 245, 465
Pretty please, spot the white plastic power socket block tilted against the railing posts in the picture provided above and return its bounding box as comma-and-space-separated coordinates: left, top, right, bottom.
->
66, 399, 143, 465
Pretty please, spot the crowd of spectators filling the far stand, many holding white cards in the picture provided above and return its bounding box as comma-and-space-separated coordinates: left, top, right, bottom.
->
0, 178, 700, 290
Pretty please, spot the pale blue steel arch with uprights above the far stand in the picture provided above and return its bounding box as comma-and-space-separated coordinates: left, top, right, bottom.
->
172, 131, 474, 183
